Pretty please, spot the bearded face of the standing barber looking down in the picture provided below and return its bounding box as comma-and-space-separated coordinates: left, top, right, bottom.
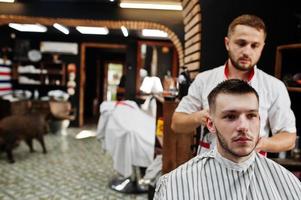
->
225, 25, 265, 71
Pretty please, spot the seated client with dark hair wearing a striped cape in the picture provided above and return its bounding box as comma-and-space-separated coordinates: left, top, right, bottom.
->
154, 79, 301, 200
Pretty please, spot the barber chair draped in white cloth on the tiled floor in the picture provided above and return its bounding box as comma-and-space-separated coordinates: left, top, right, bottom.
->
97, 101, 156, 194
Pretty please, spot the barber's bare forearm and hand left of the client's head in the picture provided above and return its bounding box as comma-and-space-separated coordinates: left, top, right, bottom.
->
171, 109, 209, 133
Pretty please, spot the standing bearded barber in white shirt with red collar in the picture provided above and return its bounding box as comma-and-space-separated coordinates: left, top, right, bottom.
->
171, 15, 296, 153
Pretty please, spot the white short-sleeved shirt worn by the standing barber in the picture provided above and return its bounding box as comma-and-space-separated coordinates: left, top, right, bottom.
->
176, 65, 296, 154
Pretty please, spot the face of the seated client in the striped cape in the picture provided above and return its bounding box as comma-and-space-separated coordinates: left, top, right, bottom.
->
207, 93, 260, 162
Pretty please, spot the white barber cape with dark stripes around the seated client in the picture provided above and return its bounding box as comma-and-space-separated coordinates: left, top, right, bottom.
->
154, 148, 301, 200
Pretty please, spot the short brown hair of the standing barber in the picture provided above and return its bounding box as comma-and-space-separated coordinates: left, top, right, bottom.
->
228, 14, 267, 37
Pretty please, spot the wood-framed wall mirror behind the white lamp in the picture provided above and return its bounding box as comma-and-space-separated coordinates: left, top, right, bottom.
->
136, 41, 179, 93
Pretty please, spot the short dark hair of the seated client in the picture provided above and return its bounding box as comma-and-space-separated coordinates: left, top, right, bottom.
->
208, 79, 259, 111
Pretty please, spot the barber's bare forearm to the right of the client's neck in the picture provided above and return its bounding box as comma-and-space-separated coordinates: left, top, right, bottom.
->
256, 131, 296, 153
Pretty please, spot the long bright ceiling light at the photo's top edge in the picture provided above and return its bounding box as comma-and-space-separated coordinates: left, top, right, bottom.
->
119, 0, 183, 10
